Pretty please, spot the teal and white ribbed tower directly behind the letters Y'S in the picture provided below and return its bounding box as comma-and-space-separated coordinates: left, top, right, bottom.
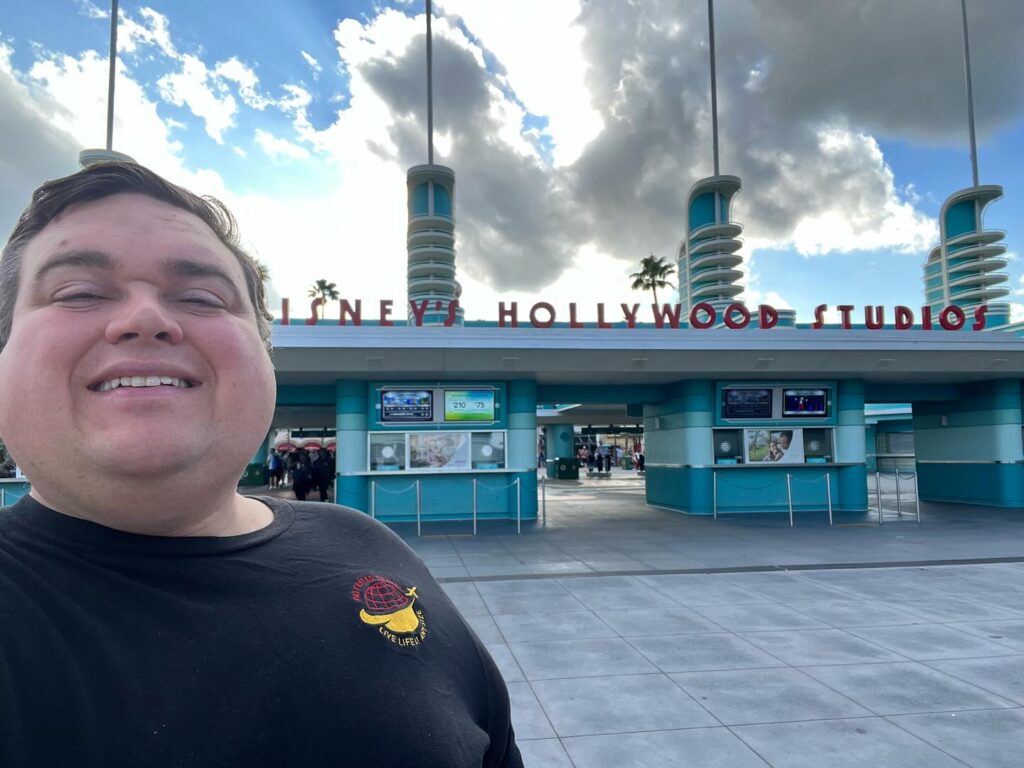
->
407, 165, 465, 326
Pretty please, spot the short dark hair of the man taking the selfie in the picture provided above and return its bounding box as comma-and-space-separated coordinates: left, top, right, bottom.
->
0, 162, 273, 350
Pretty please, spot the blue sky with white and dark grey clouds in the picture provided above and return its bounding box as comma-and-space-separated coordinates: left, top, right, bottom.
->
0, 0, 1024, 322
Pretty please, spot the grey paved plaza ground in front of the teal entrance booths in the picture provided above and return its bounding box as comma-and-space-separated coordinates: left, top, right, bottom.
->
249, 473, 1024, 768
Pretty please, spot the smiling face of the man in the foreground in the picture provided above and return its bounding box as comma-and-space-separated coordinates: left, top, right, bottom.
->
0, 195, 274, 488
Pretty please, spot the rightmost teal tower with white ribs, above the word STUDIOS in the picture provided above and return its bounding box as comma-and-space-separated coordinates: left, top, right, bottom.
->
925, 184, 1010, 328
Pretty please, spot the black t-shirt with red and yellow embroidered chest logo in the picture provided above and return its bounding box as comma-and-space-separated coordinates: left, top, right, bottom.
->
0, 498, 521, 768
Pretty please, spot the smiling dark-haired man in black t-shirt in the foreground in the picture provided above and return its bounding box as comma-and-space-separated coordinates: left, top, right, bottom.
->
0, 159, 521, 768
